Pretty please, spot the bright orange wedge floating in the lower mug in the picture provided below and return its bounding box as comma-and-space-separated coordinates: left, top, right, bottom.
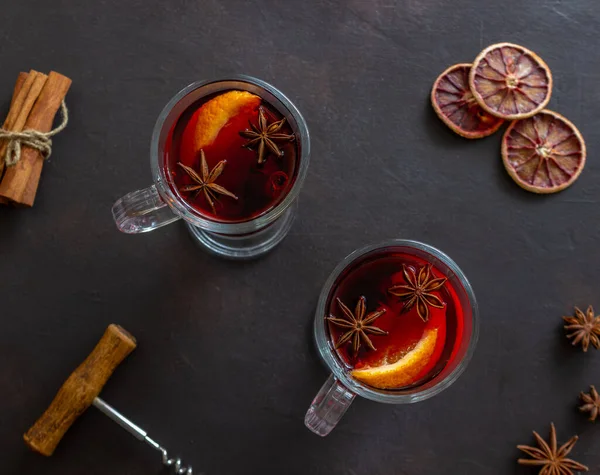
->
352, 328, 438, 389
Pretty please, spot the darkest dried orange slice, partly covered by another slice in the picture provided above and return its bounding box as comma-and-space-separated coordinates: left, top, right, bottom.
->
431, 63, 504, 139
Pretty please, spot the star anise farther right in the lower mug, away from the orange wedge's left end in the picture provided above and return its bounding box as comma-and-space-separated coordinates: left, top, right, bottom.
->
388, 264, 448, 322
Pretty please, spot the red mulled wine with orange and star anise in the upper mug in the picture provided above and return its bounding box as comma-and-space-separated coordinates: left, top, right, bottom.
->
164, 90, 300, 223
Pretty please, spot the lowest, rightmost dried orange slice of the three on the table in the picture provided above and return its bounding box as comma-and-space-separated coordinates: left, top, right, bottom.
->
502, 110, 586, 193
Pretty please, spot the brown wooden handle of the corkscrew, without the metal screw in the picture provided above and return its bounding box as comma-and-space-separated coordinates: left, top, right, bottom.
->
23, 324, 136, 456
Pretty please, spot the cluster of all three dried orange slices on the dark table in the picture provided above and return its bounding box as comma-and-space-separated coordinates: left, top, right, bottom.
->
431, 43, 586, 193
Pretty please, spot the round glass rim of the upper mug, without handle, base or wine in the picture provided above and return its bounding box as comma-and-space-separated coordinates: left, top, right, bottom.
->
150, 74, 310, 234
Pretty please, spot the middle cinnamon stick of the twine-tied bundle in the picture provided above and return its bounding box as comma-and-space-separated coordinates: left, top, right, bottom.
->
0, 70, 48, 175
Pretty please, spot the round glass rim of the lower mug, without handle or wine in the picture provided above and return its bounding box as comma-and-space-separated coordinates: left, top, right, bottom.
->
313, 239, 479, 404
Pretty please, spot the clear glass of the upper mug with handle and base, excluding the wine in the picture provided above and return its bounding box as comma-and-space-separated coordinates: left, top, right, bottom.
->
112, 75, 310, 259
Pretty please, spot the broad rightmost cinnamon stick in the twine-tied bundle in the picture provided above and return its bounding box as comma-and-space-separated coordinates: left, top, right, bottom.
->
0, 71, 71, 206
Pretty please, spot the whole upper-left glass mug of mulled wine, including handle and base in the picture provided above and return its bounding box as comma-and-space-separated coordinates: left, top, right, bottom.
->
112, 75, 310, 259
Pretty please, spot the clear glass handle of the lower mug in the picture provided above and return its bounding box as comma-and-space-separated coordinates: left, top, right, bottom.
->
304, 375, 354, 437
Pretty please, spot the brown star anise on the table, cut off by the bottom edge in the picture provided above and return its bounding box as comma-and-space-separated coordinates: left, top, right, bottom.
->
517, 424, 589, 475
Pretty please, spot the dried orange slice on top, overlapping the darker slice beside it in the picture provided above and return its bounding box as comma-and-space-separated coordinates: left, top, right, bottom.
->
469, 43, 552, 119
